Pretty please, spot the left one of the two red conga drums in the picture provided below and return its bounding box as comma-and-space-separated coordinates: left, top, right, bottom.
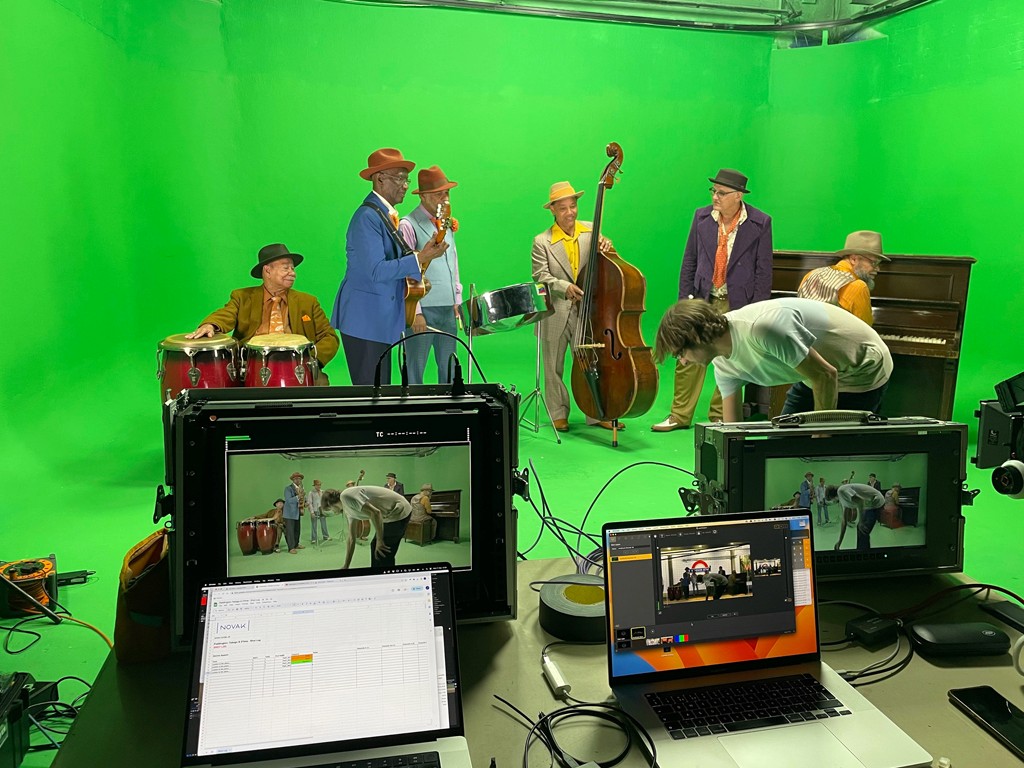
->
157, 334, 242, 401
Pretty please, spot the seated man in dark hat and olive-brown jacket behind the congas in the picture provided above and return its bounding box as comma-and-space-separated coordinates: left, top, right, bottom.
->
186, 243, 339, 384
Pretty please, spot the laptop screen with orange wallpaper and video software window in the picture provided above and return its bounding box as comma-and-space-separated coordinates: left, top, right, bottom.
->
603, 509, 818, 684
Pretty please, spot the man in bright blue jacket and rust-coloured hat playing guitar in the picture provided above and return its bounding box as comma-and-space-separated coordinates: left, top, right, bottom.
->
331, 148, 447, 384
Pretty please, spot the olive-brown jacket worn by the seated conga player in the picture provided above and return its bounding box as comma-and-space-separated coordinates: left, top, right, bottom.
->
201, 285, 339, 367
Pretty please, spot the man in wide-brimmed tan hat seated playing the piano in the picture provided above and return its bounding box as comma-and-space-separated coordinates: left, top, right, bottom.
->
797, 229, 890, 326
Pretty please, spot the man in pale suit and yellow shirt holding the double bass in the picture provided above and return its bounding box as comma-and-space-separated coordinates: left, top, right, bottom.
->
532, 181, 625, 432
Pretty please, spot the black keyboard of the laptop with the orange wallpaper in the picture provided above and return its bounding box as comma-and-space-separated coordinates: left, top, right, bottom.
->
647, 675, 850, 738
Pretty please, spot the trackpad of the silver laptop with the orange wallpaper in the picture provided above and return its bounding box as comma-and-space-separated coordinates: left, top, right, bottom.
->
718, 723, 863, 768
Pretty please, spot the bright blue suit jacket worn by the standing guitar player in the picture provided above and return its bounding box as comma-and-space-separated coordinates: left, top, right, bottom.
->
331, 193, 420, 344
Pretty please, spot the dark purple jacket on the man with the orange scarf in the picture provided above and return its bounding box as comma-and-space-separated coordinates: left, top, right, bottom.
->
679, 203, 772, 309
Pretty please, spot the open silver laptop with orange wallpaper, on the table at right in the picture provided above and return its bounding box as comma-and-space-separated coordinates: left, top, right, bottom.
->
603, 510, 932, 768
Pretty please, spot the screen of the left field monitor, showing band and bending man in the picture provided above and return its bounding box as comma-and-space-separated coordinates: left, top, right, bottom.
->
225, 443, 472, 577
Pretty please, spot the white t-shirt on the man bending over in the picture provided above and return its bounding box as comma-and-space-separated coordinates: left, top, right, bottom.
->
714, 299, 893, 397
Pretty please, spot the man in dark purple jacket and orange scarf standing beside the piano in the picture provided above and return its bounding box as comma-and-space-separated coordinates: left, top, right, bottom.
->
651, 168, 772, 432
